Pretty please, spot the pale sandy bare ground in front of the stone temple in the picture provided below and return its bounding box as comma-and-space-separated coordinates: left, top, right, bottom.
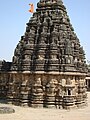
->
0, 92, 90, 120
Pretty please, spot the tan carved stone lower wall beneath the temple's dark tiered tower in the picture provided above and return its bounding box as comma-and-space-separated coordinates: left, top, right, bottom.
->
0, 73, 87, 109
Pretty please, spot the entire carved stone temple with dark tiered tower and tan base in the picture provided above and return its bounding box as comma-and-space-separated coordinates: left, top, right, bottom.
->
0, 0, 87, 109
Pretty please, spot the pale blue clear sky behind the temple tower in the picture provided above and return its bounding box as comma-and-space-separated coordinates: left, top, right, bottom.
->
0, 0, 90, 61
